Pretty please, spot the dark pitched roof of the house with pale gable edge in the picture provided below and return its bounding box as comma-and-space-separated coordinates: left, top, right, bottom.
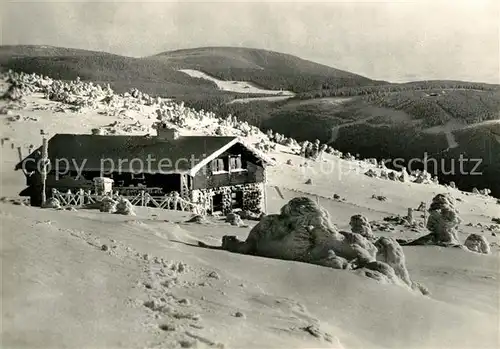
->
15, 134, 273, 176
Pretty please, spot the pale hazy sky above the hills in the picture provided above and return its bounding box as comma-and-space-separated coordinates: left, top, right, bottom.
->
0, 0, 500, 83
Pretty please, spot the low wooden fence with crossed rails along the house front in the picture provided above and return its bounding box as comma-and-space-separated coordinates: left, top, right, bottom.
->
52, 189, 207, 215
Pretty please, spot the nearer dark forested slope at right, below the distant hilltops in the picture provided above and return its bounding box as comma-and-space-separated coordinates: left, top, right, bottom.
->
188, 91, 500, 197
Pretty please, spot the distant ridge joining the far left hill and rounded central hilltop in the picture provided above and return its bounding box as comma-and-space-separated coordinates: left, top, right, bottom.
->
0, 45, 381, 97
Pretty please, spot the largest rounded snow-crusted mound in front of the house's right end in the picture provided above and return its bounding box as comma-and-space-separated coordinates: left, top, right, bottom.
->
223, 197, 376, 262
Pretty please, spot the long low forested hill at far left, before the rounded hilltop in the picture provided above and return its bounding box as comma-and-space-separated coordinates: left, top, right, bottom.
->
0, 46, 226, 97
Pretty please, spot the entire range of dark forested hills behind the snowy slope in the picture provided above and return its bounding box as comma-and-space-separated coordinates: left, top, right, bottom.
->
0, 46, 500, 196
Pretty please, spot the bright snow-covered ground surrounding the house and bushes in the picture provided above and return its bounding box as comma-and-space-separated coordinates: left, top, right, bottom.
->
0, 76, 500, 349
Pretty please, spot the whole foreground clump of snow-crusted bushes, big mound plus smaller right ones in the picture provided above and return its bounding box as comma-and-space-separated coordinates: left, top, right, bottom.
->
211, 197, 421, 291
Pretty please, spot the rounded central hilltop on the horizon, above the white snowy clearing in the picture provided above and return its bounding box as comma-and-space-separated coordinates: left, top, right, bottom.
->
149, 47, 384, 92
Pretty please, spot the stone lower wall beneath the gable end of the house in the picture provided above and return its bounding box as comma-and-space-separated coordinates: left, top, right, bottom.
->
191, 183, 264, 214
